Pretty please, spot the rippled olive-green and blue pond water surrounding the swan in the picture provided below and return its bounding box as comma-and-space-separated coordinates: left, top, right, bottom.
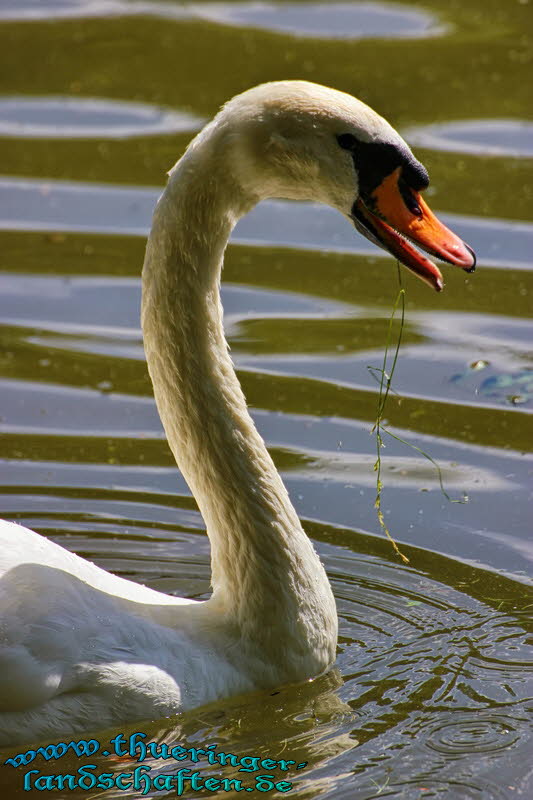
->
0, 0, 533, 800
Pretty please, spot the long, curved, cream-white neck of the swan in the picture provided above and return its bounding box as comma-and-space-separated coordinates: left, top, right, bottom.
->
142, 134, 336, 655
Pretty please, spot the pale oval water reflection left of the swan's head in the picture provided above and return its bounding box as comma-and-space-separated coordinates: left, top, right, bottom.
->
0, 97, 204, 139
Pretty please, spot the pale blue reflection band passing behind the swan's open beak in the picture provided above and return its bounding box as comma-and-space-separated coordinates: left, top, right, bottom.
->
4, 178, 533, 271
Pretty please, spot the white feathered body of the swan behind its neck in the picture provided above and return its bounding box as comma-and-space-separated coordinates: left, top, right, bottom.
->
0, 522, 250, 745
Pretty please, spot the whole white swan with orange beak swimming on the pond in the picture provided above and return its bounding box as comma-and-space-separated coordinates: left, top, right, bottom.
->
0, 81, 475, 745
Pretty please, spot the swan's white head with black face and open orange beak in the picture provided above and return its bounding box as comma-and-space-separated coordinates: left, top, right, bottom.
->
216, 81, 476, 290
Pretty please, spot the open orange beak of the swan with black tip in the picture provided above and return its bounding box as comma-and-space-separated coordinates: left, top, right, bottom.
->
352, 167, 476, 292
